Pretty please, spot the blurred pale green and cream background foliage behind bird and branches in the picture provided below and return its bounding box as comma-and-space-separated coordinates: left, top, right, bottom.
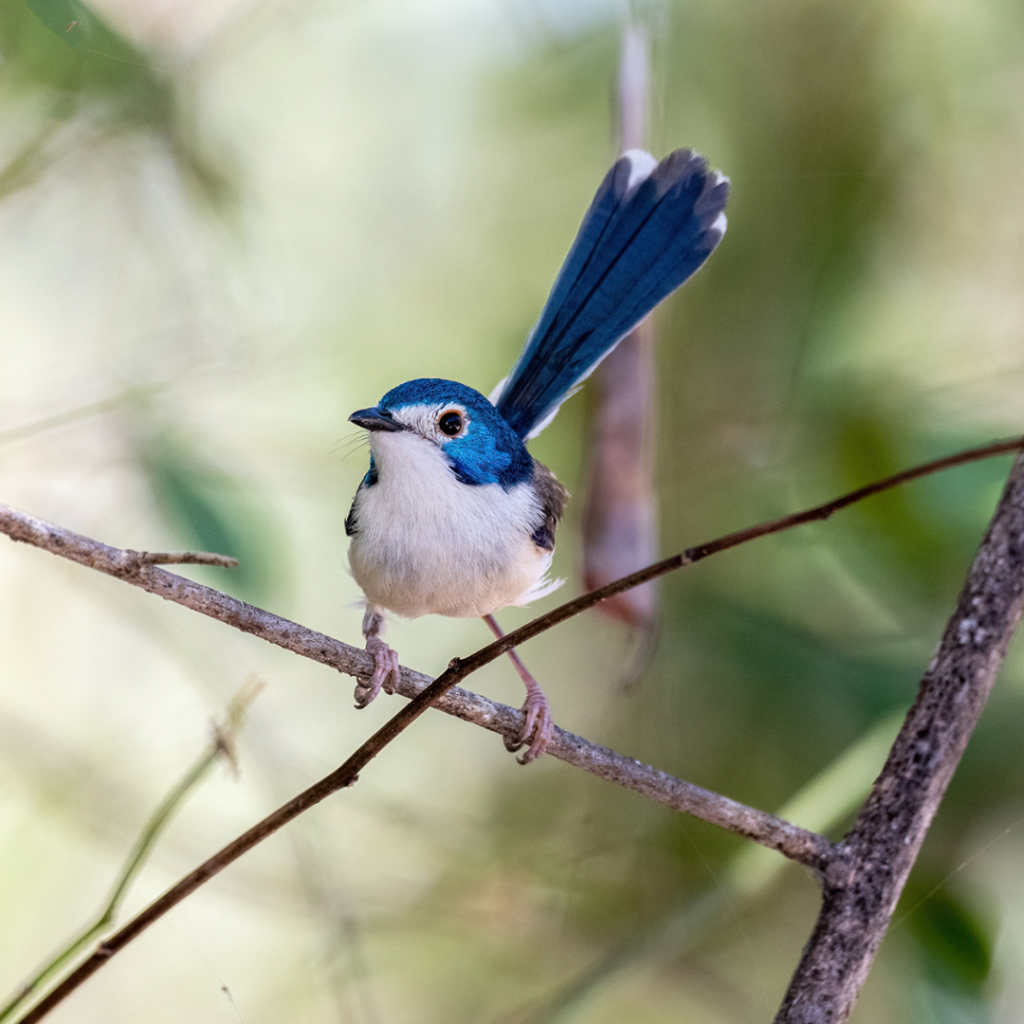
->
0, 0, 1024, 1024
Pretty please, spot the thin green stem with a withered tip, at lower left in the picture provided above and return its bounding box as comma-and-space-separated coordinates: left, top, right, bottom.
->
0, 681, 259, 1022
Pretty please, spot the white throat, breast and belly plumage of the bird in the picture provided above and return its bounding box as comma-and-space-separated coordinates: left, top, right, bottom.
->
348, 431, 562, 618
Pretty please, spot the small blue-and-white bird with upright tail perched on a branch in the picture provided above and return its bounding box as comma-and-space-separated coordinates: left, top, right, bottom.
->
345, 150, 729, 764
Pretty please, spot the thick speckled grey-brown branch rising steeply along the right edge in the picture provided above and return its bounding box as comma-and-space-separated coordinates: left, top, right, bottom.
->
775, 457, 1024, 1024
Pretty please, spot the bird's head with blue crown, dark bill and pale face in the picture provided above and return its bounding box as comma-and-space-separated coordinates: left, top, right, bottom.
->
349, 377, 534, 487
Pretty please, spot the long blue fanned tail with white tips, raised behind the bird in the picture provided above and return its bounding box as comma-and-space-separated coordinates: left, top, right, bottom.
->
493, 150, 729, 439
